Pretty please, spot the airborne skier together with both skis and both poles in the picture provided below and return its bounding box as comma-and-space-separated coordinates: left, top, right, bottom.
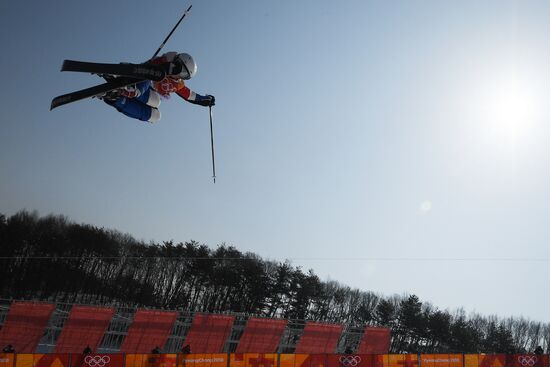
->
50, 5, 220, 183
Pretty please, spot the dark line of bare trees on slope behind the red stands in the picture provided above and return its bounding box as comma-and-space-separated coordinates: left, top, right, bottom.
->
0, 211, 550, 353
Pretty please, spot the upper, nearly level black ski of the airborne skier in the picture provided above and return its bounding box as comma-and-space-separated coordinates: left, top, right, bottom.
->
61, 60, 168, 81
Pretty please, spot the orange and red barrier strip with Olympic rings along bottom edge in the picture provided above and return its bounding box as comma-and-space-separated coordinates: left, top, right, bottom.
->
0, 353, 550, 367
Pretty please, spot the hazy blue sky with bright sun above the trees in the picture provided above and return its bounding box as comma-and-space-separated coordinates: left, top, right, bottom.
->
0, 0, 550, 321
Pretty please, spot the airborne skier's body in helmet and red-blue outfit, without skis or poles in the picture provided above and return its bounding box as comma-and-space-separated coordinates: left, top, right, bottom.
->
102, 52, 215, 123
